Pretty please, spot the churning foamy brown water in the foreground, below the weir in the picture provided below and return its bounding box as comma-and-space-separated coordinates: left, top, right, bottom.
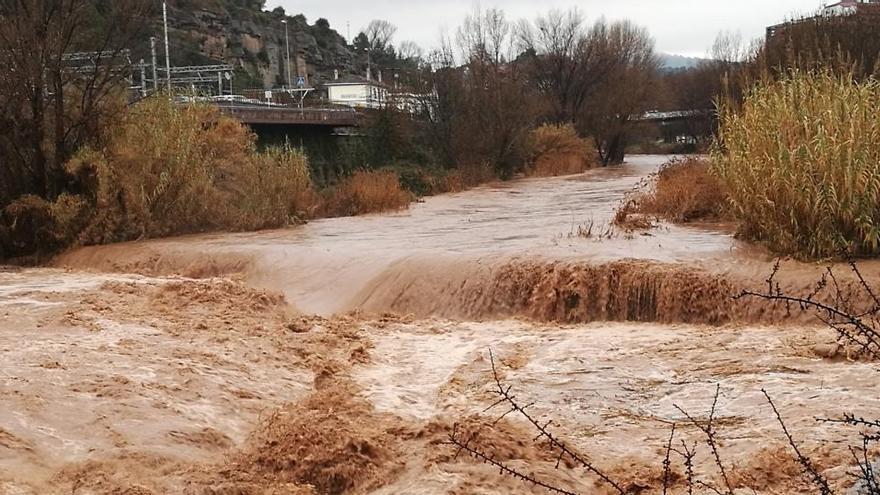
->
0, 269, 880, 495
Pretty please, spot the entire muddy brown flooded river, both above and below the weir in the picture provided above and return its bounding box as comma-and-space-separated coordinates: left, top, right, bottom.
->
0, 156, 880, 495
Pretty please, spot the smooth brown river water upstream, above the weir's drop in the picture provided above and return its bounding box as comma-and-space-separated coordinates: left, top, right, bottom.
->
57, 156, 741, 316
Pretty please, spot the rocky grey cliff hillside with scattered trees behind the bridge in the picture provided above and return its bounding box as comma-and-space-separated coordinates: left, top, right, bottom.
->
155, 0, 365, 89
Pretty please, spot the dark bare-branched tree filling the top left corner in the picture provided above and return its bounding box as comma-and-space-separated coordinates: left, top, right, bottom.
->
0, 0, 150, 207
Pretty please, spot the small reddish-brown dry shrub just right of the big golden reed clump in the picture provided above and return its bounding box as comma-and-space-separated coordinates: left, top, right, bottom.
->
317, 170, 413, 217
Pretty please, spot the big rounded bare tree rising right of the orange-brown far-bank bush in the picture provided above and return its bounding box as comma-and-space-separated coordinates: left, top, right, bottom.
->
518, 10, 658, 164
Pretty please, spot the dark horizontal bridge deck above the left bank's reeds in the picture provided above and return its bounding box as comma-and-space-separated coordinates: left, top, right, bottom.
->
218, 105, 359, 127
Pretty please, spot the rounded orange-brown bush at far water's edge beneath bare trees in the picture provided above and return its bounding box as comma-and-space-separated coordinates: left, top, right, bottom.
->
526, 124, 599, 177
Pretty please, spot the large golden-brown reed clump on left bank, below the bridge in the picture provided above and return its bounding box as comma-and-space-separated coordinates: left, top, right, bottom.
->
67, 97, 311, 243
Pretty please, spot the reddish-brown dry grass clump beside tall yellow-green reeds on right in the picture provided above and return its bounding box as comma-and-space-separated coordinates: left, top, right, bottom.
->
615, 157, 727, 228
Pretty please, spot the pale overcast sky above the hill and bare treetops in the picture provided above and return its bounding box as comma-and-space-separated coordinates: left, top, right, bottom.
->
266, 0, 832, 56
